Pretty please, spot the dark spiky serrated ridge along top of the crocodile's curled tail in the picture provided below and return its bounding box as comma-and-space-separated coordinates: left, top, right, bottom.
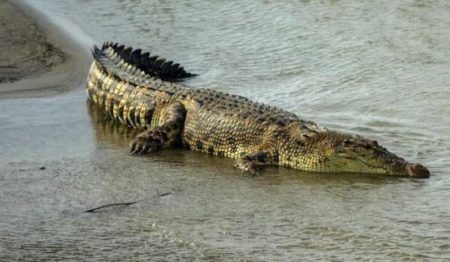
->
98, 42, 196, 82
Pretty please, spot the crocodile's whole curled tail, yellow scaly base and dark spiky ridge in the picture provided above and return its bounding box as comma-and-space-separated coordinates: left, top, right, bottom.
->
87, 43, 194, 131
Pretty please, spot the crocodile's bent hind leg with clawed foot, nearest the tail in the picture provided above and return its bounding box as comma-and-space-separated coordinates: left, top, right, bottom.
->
130, 103, 186, 155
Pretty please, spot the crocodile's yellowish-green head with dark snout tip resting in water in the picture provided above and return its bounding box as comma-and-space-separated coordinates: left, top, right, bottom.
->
294, 131, 430, 178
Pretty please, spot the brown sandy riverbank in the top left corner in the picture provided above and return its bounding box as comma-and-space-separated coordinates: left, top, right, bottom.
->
0, 1, 88, 99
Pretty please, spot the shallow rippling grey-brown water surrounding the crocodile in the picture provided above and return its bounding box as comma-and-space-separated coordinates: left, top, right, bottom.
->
0, 0, 450, 261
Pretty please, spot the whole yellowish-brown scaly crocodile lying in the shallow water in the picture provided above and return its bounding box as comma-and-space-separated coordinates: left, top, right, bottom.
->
86, 42, 430, 178
